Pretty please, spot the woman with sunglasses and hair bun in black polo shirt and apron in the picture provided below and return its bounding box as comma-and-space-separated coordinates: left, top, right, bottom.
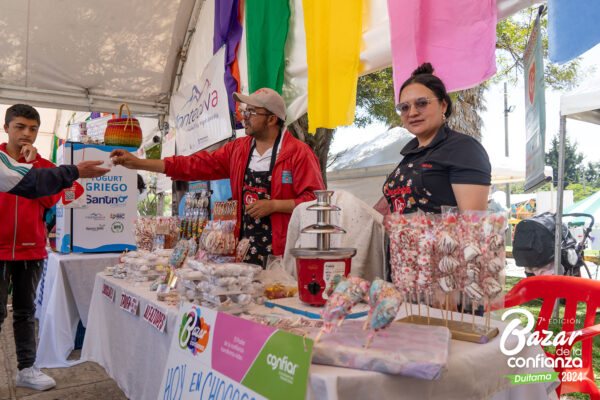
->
383, 63, 491, 213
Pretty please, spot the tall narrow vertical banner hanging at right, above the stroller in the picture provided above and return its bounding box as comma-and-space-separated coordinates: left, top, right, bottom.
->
523, 15, 546, 191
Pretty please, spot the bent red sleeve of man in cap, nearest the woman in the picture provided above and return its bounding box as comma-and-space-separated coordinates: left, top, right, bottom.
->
292, 145, 325, 206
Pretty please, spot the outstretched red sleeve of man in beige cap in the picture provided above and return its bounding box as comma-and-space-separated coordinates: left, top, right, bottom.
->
164, 141, 235, 181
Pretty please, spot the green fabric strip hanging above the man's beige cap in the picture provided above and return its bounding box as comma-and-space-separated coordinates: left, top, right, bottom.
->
246, 0, 290, 94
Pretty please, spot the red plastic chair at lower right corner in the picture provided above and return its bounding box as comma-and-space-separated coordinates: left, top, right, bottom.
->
504, 276, 600, 400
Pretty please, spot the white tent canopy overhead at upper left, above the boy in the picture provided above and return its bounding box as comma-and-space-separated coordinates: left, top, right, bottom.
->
0, 0, 202, 114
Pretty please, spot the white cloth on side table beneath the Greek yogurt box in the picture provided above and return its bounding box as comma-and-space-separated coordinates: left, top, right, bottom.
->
36, 253, 119, 368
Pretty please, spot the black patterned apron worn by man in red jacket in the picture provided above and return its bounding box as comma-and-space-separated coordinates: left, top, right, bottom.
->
240, 133, 281, 268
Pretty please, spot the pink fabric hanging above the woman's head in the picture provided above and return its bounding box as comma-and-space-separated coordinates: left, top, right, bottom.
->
388, 0, 497, 103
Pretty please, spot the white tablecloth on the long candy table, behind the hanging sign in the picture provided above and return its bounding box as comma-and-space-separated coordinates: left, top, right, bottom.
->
82, 274, 558, 400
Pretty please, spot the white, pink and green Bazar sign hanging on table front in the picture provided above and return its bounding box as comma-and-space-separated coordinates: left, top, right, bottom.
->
158, 303, 313, 400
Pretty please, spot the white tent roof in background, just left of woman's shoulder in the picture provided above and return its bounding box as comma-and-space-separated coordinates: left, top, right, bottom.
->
327, 127, 414, 171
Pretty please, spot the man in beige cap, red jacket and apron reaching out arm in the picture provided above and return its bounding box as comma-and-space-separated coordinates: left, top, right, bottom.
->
111, 88, 325, 267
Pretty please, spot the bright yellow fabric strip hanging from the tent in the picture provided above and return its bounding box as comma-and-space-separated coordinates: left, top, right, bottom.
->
302, 0, 363, 133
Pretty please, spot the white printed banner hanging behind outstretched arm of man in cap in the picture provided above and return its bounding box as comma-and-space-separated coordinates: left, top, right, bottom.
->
169, 47, 233, 156
